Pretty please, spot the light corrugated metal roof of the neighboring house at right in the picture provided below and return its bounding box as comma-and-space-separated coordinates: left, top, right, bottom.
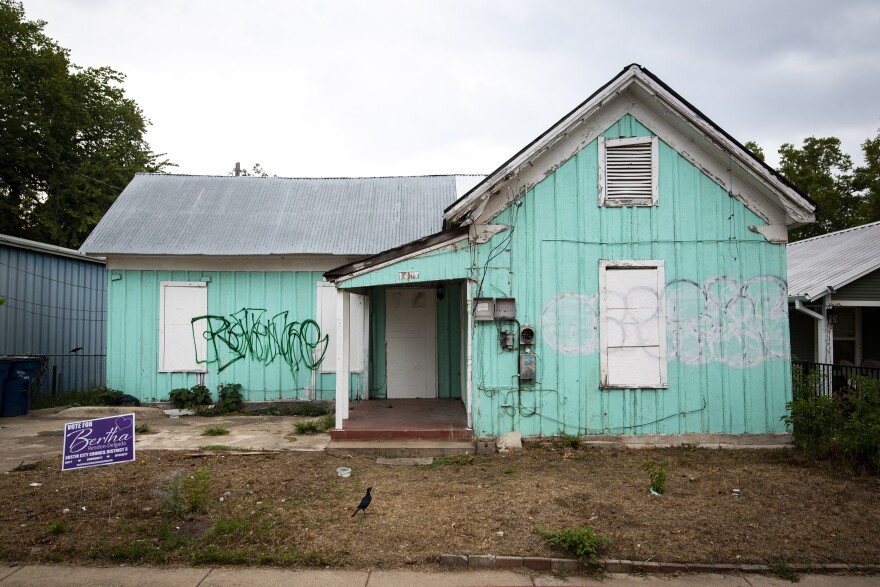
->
786, 222, 880, 300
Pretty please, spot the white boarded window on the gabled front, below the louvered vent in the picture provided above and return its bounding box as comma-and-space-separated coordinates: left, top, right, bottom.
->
599, 261, 667, 388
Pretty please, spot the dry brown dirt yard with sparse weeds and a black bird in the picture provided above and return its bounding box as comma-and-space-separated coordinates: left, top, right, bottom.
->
0, 444, 880, 569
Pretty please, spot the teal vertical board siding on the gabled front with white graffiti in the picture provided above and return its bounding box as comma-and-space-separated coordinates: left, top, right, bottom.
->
470, 115, 791, 435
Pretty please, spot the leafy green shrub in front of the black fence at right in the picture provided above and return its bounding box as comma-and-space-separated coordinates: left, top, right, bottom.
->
782, 377, 880, 471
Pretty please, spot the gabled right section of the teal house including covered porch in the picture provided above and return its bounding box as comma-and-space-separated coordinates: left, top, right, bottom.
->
326, 65, 815, 436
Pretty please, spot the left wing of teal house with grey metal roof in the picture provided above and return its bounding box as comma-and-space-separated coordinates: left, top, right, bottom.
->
80, 174, 482, 401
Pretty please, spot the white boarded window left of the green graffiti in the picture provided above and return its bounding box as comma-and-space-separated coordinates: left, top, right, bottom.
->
159, 281, 208, 373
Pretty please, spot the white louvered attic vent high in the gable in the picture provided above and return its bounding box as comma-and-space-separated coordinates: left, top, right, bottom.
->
599, 137, 658, 206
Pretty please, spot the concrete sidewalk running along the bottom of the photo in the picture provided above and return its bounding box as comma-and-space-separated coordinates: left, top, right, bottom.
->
0, 565, 880, 587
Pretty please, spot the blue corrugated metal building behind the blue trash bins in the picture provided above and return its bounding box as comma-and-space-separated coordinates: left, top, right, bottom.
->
0, 235, 107, 393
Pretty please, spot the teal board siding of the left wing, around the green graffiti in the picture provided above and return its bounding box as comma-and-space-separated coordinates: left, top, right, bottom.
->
107, 270, 363, 401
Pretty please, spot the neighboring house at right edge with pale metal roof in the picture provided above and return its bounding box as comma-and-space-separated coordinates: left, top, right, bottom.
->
787, 222, 880, 387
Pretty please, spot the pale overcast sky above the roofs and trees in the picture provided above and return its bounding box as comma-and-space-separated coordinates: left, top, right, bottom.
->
24, 0, 880, 177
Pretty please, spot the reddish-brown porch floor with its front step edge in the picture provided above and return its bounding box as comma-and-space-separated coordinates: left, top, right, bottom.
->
330, 399, 473, 440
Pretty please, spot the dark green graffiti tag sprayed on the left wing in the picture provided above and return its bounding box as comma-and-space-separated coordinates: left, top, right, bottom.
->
192, 308, 330, 374
